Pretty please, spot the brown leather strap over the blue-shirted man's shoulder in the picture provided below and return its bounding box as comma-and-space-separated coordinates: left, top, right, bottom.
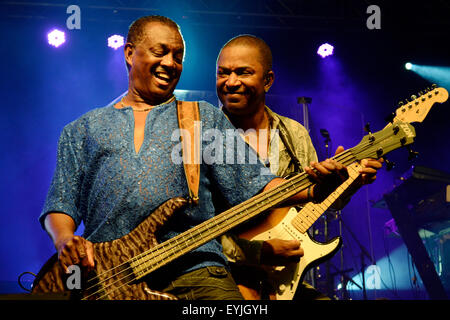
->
177, 101, 201, 204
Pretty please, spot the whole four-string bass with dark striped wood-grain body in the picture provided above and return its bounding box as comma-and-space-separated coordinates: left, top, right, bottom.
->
32, 86, 446, 300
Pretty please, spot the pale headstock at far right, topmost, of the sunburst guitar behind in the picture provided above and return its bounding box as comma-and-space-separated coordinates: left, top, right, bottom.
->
393, 84, 448, 123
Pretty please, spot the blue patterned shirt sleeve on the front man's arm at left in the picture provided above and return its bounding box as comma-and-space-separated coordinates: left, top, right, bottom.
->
39, 125, 83, 228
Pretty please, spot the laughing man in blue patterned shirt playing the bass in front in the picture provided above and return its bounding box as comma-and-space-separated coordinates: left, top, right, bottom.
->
39, 16, 345, 299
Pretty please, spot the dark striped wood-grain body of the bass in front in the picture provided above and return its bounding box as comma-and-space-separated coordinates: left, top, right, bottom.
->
32, 198, 187, 300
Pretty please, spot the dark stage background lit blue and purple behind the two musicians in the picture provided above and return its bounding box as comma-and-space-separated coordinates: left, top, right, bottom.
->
0, 0, 450, 300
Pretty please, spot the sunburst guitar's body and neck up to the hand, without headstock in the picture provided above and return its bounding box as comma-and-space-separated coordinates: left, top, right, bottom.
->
240, 162, 361, 300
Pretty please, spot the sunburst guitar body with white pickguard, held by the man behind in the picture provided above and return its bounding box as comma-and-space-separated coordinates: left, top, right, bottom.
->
238, 207, 342, 300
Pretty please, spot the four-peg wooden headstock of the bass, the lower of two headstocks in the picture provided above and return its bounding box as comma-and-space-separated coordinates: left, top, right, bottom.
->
352, 121, 416, 160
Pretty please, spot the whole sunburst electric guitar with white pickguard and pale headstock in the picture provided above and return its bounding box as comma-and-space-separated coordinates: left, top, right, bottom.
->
238, 86, 448, 300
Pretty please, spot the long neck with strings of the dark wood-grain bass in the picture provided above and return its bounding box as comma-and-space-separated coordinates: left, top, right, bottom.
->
129, 149, 356, 279
